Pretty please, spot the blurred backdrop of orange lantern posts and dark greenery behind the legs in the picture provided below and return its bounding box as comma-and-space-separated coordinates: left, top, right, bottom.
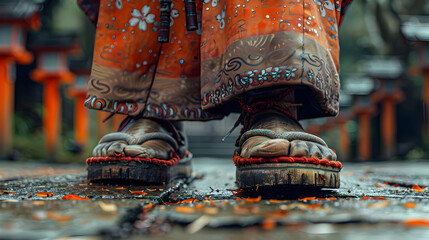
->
0, 0, 429, 163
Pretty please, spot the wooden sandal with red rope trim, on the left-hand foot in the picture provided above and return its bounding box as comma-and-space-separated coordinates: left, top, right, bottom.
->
86, 118, 192, 184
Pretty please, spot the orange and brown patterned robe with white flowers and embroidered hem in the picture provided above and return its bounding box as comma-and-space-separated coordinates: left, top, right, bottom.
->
81, 0, 351, 120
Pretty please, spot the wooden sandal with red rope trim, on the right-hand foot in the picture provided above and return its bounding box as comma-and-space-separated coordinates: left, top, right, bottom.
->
233, 129, 342, 188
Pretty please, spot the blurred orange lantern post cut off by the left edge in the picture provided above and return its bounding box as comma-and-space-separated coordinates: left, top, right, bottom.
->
0, 7, 40, 156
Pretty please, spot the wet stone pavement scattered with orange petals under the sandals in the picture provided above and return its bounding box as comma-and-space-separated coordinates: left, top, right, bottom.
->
0, 158, 429, 239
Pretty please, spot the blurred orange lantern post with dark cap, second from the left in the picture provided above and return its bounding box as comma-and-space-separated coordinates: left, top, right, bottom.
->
31, 34, 79, 158
